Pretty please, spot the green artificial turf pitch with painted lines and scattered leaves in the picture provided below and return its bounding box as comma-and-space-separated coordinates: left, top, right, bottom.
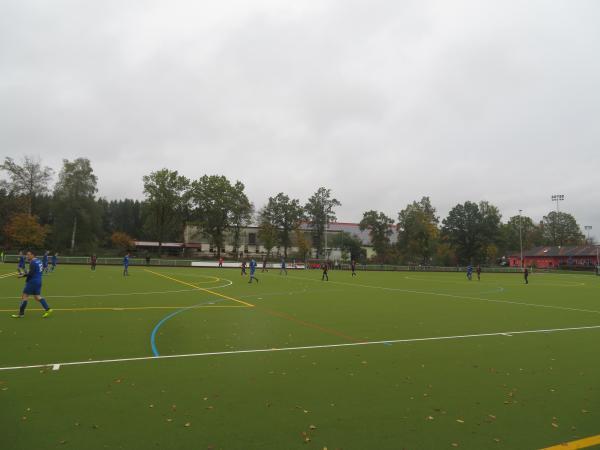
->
0, 264, 600, 450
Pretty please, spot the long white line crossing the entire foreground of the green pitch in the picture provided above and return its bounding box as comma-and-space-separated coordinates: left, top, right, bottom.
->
0, 325, 600, 371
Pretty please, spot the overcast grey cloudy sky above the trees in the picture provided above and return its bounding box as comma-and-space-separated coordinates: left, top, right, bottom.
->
0, 0, 600, 236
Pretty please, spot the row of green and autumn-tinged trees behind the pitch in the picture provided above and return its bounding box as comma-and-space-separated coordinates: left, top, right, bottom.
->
0, 156, 585, 265
